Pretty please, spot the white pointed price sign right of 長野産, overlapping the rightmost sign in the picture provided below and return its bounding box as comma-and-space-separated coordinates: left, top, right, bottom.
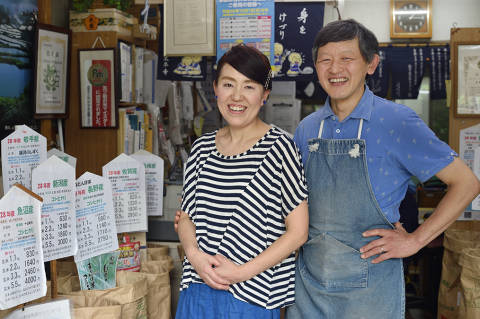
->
102, 154, 148, 233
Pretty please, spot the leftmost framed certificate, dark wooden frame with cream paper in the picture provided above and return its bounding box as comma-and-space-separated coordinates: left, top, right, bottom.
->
33, 23, 72, 119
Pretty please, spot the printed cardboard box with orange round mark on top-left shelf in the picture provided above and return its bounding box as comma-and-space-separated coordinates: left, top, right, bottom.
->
70, 8, 134, 36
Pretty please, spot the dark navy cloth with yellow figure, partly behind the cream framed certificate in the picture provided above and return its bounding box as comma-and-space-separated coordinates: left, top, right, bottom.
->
157, 6, 207, 81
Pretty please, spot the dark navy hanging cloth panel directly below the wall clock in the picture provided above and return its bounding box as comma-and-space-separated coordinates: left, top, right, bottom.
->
387, 47, 429, 100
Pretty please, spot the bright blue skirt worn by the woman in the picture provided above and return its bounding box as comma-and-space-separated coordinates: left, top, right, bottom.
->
175, 283, 280, 319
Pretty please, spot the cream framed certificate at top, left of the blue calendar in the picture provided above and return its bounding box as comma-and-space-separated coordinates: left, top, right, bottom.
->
164, 0, 215, 56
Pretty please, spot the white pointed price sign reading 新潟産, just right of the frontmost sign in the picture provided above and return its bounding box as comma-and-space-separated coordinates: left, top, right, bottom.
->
32, 155, 77, 261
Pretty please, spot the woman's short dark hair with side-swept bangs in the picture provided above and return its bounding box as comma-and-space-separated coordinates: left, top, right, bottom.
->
215, 44, 272, 90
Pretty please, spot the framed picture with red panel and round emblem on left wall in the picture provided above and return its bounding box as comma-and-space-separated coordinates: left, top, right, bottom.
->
78, 48, 118, 128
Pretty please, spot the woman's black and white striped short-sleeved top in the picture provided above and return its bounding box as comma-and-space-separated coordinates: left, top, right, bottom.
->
180, 128, 308, 309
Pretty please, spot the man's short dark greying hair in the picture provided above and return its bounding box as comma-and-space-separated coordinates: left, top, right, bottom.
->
312, 19, 379, 64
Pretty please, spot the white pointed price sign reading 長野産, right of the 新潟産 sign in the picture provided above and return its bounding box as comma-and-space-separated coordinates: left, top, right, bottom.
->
75, 172, 118, 262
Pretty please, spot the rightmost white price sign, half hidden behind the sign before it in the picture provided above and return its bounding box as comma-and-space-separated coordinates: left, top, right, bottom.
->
130, 150, 164, 216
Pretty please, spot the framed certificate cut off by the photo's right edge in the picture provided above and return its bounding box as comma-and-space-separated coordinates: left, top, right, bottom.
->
452, 42, 480, 117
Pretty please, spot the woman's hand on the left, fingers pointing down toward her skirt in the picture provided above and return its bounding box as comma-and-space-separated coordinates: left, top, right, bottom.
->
187, 249, 230, 290
